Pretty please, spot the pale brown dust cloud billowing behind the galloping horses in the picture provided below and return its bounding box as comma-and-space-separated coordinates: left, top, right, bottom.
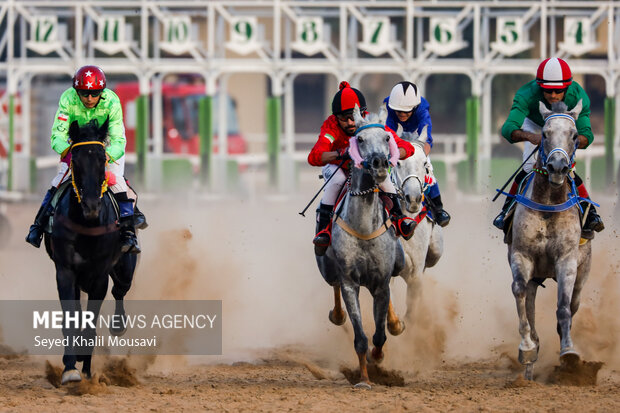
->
0, 172, 620, 378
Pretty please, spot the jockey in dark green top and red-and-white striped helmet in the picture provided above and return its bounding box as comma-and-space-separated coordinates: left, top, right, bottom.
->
493, 57, 605, 239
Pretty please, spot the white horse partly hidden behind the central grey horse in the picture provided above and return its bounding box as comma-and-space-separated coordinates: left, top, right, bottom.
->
388, 127, 443, 321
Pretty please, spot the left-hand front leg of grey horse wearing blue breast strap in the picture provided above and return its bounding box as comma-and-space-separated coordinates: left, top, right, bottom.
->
510, 253, 538, 365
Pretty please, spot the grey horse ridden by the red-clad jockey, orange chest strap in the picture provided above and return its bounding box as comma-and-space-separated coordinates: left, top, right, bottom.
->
316, 106, 404, 389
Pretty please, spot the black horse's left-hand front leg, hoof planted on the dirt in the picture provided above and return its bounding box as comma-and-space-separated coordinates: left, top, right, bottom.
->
56, 264, 82, 384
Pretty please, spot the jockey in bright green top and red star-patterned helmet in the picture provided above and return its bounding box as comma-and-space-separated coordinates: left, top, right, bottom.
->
26, 66, 146, 254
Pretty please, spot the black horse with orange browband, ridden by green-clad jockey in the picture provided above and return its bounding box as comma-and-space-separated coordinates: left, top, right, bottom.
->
45, 120, 137, 384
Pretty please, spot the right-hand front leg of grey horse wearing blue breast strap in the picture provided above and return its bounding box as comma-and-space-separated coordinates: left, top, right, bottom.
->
556, 257, 579, 361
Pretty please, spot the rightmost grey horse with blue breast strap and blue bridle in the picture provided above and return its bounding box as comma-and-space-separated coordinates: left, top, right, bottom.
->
508, 101, 592, 380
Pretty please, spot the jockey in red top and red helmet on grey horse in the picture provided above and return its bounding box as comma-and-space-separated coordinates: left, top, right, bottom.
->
308, 82, 416, 255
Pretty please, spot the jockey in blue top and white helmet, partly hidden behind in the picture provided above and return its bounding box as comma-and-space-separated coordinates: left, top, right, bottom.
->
383, 81, 450, 227
